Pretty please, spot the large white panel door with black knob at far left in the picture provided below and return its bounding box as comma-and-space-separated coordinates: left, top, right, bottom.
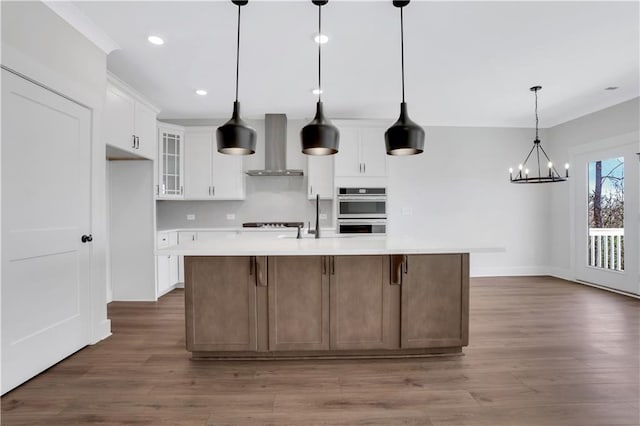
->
2, 70, 91, 393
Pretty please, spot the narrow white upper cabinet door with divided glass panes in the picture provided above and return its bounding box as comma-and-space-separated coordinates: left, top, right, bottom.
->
157, 127, 184, 199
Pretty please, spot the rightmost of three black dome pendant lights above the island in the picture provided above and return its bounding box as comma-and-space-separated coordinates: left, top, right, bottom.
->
384, 0, 424, 155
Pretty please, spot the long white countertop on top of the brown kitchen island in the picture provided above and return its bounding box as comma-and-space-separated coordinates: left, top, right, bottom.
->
156, 234, 505, 256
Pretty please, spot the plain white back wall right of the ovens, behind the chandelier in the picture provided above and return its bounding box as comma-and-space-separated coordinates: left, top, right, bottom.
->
389, 127, 549, 276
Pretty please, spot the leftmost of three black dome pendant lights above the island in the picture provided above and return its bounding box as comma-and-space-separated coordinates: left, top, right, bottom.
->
216, 0, 256, 155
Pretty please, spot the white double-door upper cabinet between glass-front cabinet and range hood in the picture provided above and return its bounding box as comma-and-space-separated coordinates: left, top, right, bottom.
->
184, 127, 245, 200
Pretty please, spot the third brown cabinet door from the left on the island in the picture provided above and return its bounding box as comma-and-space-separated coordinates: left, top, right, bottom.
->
330, 256, 397, 349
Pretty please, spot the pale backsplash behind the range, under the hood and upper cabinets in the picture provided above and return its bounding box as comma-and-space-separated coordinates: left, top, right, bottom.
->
156, 176, 334, 229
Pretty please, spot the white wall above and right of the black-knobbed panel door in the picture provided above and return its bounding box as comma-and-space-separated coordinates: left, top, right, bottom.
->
1, 1, 111, 342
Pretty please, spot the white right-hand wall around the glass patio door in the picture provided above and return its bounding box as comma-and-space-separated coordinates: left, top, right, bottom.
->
546, 98, 640, 279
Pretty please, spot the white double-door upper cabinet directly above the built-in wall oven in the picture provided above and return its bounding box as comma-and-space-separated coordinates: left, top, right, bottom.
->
335, 120, 387, 177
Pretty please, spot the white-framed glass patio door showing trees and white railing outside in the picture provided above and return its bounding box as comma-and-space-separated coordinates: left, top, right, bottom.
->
574, 142, 640, 294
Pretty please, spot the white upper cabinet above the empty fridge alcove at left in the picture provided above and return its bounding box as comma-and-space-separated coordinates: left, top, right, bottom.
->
104, 76, 157, 160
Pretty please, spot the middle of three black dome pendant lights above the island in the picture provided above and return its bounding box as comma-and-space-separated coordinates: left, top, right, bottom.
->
300, 0, 340, 155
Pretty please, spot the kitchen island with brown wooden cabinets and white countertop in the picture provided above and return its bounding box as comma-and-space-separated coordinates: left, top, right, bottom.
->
158, 235, 480, 358
